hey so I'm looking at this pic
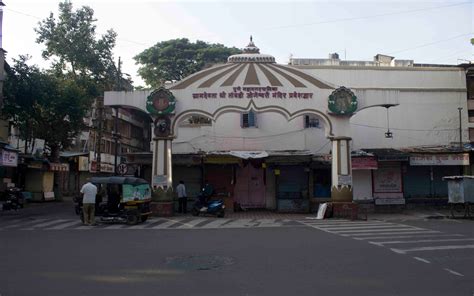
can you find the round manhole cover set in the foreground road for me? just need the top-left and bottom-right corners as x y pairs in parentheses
(166, 255), (234, 270)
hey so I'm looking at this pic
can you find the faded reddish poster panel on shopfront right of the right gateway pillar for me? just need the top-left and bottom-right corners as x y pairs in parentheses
(373, 164), (403, 193)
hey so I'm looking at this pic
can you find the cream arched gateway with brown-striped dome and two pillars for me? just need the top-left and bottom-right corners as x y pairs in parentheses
(105, 41), (398, 205)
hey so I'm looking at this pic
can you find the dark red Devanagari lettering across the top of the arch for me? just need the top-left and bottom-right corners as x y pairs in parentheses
(192, 86), (313, 100)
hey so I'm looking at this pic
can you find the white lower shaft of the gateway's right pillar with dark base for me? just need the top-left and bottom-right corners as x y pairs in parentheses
(331, 137), (352, 202)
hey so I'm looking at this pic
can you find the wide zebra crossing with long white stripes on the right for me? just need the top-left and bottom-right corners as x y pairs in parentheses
(302, 220), (474, 261)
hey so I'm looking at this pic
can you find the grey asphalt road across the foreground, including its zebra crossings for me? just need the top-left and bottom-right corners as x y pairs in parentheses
(0, 205), (474, 296)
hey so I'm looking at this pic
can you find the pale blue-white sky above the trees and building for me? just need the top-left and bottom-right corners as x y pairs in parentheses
(2, 0), (474, 86)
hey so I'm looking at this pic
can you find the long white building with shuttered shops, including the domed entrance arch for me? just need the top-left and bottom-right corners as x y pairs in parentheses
(104, 40), (469, 211)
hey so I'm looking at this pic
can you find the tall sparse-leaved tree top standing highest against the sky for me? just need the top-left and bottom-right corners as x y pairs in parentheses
(35, 1), (123, 95)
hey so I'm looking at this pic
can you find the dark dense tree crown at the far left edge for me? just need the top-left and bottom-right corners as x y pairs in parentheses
(3, 56), (91, 161)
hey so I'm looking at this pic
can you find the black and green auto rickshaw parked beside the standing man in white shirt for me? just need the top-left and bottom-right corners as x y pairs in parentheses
(75, 176), (151, 224)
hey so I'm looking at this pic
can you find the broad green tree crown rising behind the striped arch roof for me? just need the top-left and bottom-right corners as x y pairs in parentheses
(134, 38), (241, 87)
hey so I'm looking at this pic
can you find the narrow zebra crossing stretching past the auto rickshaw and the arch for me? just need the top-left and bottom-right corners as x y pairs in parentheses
(0, 217), (302, 233)
